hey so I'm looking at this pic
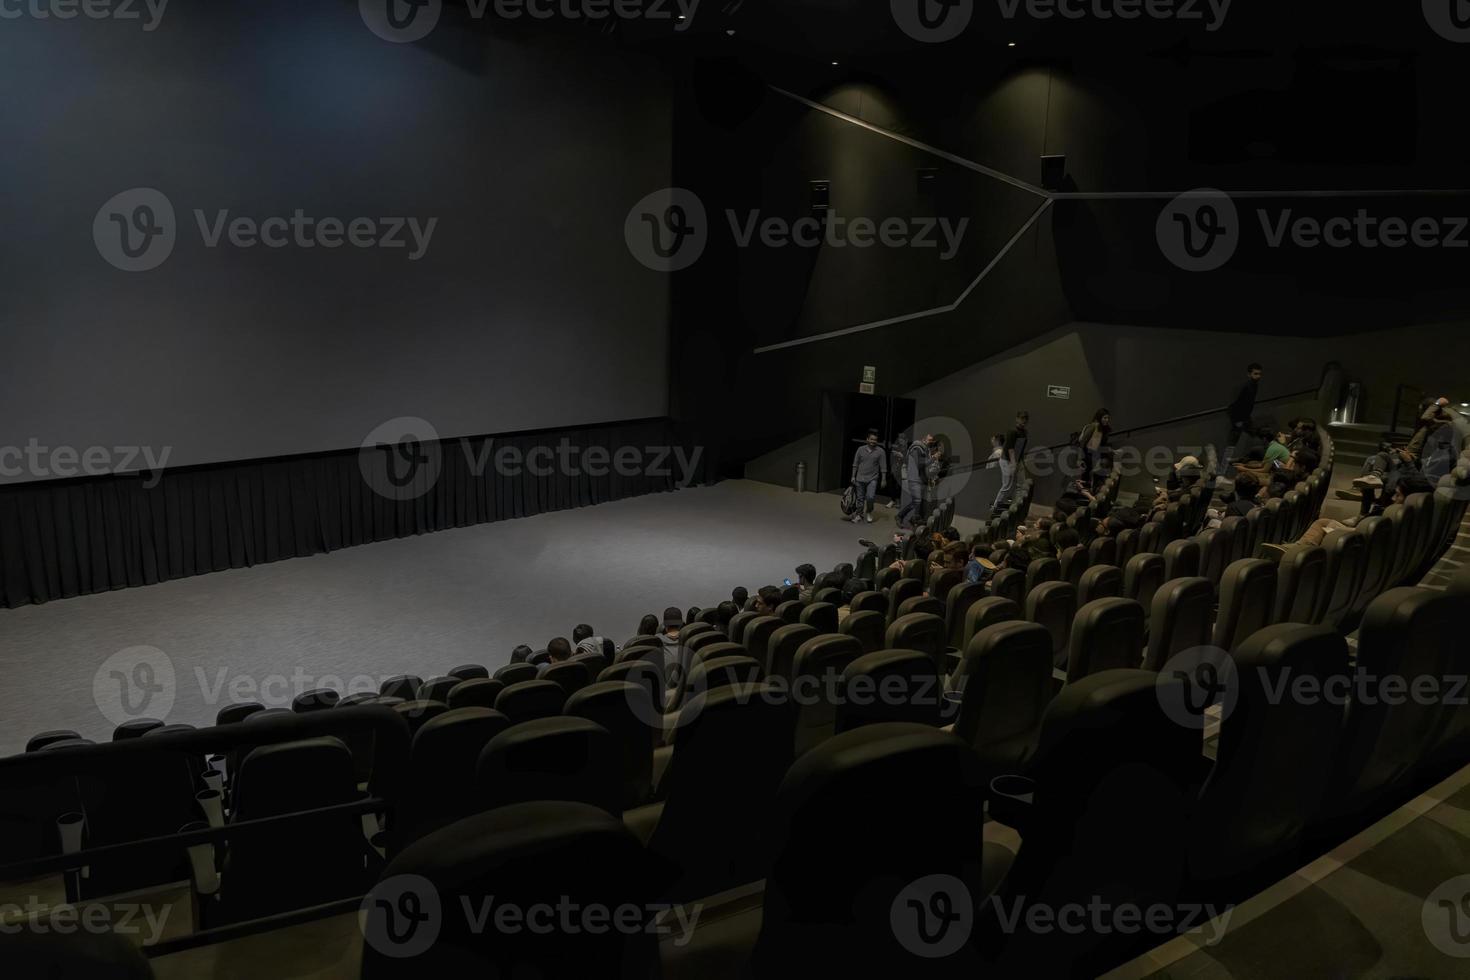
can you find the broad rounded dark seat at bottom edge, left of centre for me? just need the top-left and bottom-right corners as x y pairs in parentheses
(354, 802), (659, 980)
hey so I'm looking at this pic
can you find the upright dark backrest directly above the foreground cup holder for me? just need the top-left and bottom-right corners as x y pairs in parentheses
(951, 620), (1053, 752)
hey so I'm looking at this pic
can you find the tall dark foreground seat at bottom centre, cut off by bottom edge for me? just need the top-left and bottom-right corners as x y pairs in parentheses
(750, 723), (985, 977)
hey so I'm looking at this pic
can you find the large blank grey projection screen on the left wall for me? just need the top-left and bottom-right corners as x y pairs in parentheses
(0, 0), (670, 482)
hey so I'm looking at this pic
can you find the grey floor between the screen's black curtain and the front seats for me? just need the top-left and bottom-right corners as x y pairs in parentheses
(0, 480), (952, 754)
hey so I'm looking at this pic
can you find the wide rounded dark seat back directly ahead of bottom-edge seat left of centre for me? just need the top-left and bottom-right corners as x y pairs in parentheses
(475, 716), (623, 814)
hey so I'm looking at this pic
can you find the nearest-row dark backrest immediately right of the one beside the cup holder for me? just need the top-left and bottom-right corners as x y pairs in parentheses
(1189, 623), (1348, 886)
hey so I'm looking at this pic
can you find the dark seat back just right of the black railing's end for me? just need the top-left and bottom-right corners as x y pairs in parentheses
(392, 708), (510, 848)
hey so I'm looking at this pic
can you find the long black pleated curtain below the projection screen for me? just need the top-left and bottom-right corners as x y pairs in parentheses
(0, 419), (703, 608)
